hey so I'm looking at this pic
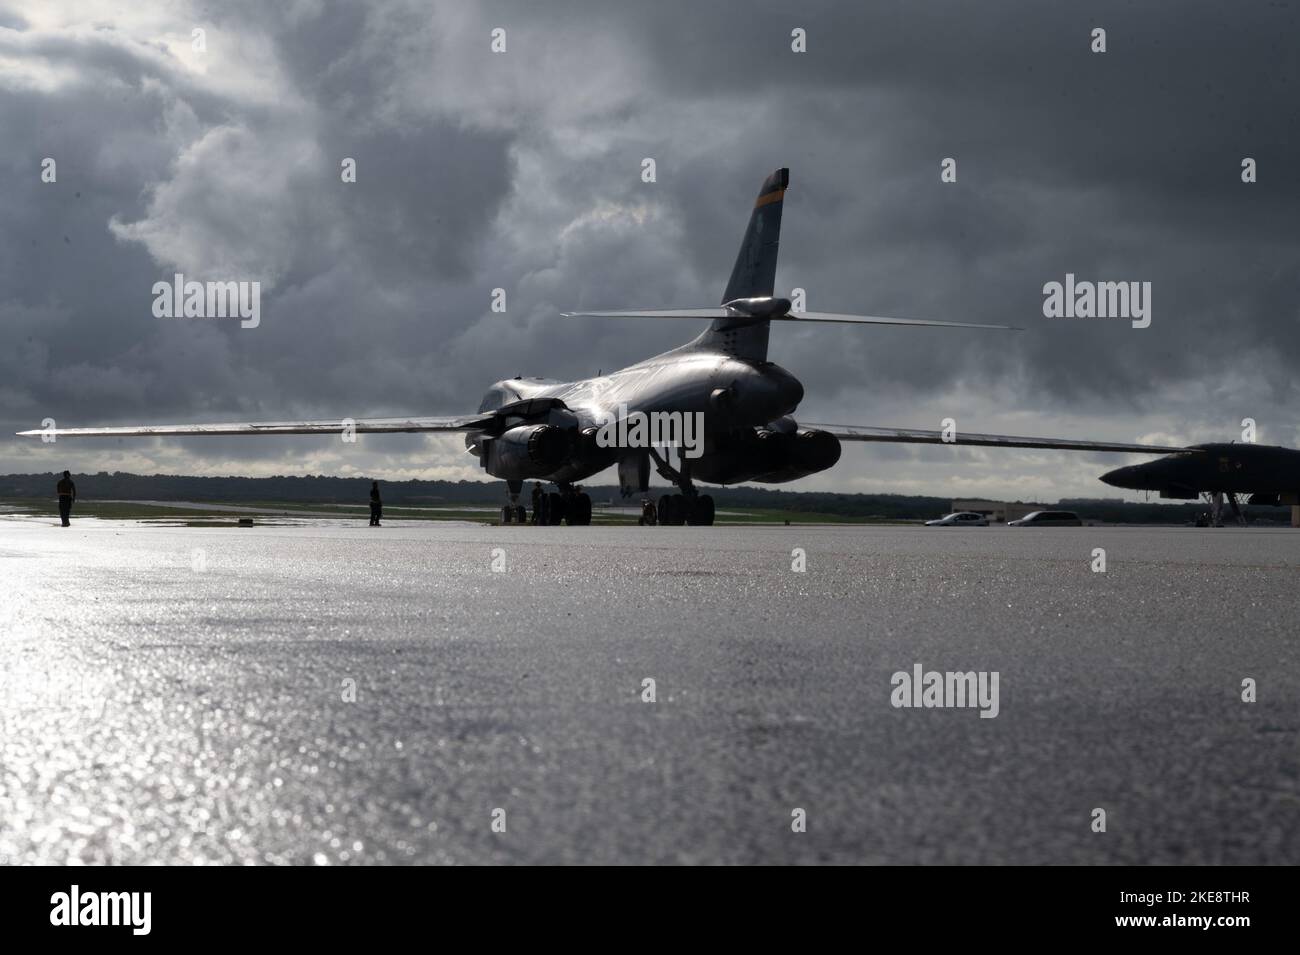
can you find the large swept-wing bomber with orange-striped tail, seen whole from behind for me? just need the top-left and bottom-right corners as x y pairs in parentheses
(21, 169), (1188, 525)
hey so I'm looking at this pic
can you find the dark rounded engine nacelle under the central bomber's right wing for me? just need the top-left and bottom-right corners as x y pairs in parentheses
(690, 421), (840, 485)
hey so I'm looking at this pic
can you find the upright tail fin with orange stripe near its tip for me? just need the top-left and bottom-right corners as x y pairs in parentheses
(696, 169), (790, 361)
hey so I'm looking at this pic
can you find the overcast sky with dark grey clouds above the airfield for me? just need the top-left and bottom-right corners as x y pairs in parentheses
(0, 0), (1300, 502)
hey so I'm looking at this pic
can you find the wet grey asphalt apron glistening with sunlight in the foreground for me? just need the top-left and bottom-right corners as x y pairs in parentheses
(0, 518), (1300, 864)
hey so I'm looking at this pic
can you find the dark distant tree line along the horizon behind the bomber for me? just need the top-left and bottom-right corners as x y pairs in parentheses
(0, 472), (1291, 524)
